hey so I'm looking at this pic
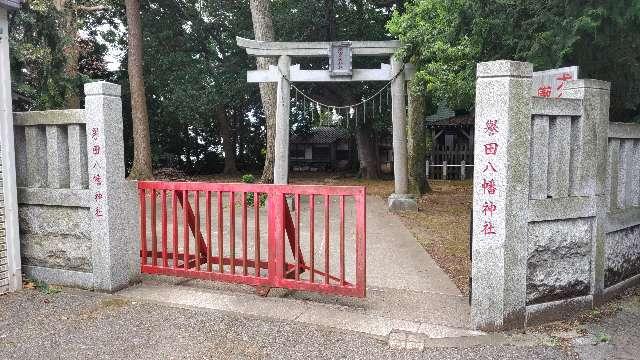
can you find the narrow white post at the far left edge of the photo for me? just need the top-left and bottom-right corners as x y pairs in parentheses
(0, 7), (22, 293)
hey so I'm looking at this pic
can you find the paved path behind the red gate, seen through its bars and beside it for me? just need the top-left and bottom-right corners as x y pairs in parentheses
(146, 193), (461, 296)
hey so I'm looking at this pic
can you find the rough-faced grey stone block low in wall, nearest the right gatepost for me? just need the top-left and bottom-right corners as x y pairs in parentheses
(527, 218), (593, 304)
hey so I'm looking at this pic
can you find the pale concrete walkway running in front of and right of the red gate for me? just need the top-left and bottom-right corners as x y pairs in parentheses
(124, 196), (480, 338)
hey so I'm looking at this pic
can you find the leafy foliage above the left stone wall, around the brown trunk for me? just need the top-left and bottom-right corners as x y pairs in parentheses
(9, 0), (114, 111)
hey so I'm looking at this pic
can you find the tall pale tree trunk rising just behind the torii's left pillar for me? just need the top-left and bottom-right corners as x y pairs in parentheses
(249, 0), (277, 183)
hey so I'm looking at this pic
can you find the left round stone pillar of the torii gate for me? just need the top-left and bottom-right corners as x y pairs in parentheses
(273, 55), (291, 184)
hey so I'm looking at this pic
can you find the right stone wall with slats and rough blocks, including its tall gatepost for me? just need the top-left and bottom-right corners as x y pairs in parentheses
(472, 61), (640, 329)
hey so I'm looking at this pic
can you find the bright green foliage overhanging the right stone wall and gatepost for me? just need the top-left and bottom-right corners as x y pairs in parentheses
(387, 0), (640, 121)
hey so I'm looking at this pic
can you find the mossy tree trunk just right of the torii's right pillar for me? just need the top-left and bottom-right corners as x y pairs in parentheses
(407, 88), (429, 195)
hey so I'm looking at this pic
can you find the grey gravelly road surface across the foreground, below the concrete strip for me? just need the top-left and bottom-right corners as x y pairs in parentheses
(0, 289), (573, 360)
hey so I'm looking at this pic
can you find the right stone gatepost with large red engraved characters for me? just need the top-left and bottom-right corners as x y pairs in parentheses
(471, 61), (533, 330)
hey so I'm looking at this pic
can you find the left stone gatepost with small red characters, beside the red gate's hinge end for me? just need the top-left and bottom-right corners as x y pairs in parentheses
(84, 81), (139, 292)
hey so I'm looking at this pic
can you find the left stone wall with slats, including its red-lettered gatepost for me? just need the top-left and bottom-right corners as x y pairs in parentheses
(14, 82), (137, 291)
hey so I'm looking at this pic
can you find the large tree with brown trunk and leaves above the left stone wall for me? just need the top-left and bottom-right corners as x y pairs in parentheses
(10, 0), (113, 110)
